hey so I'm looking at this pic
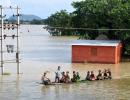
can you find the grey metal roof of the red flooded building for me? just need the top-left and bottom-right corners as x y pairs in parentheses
(72, 40), (121, 46)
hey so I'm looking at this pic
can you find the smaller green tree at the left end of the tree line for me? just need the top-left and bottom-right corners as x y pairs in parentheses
(44, 10), (73, 35)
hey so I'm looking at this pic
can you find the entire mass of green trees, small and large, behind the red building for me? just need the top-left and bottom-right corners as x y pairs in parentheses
(44, 0), (130, 55)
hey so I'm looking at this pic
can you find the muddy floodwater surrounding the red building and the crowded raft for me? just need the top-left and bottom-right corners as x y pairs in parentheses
(0, 25), (130, 100)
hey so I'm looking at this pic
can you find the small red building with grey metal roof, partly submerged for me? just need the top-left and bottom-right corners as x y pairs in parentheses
(72, 40), (122, 64)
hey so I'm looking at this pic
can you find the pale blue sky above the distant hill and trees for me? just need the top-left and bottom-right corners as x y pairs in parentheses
(0, 0), (81, 18)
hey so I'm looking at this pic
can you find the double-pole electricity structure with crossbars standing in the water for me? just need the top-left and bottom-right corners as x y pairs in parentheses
(0, 5), (20, 75)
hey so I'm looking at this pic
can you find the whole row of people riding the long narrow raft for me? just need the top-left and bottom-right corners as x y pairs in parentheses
(41, 66), (112, 85)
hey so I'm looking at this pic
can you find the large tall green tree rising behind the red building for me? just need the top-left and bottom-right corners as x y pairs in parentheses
(72, 0), (130, 40)
